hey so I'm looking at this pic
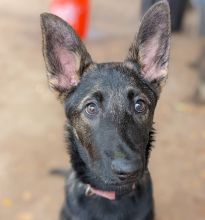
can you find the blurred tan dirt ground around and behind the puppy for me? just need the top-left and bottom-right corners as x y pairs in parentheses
(0, 0), (205, 220)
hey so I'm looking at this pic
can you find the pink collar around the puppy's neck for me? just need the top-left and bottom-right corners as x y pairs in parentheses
(86, 183), (136, 201)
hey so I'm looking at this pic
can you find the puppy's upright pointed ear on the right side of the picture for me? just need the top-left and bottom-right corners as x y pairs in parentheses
(125, 0), (170, 90)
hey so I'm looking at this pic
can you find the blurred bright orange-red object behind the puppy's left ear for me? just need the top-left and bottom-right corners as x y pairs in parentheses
(50, 0), (89, 39)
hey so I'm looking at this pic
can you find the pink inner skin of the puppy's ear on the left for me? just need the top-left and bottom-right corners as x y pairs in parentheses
(55, 48), (79, 89)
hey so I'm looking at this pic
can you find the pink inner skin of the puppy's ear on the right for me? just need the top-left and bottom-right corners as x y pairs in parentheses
(139, 35), (165, 80)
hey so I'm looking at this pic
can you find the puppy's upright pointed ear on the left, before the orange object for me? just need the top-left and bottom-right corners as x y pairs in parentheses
(41, 13), (92, 94)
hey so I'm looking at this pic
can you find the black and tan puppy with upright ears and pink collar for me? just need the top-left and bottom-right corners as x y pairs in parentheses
(41, 1), (170, 220)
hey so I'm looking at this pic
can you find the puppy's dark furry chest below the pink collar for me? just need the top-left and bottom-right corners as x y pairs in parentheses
(61, 174), (153, 220)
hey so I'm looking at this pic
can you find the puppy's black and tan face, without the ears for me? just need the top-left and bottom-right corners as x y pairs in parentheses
(65, 63), (157, 190)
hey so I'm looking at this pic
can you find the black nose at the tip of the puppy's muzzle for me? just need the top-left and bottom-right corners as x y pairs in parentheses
(111, 159), (141, 180)
